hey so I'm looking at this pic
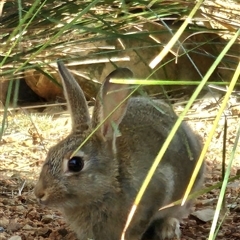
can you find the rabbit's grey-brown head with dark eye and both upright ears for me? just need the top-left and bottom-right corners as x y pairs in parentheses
(35, 62), (132, 208)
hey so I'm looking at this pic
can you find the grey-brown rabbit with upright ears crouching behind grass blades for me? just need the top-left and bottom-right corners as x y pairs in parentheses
(34, 61), (204, 240)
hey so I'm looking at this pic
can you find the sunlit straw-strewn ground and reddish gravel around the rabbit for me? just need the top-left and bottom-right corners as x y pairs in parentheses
(0, 93), (240, 240)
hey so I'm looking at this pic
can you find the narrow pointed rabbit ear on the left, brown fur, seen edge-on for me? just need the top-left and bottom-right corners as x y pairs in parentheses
(57, 61), (90, 132)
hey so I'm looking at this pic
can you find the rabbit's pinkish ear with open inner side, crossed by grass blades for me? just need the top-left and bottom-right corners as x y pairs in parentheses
(93, 68), (133, 140)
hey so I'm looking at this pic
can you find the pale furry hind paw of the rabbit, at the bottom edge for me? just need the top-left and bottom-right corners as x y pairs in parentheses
(159, 218), (181, 240)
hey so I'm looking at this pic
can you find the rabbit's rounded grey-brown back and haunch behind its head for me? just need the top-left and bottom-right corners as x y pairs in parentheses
(113, 97), (204, 239)
